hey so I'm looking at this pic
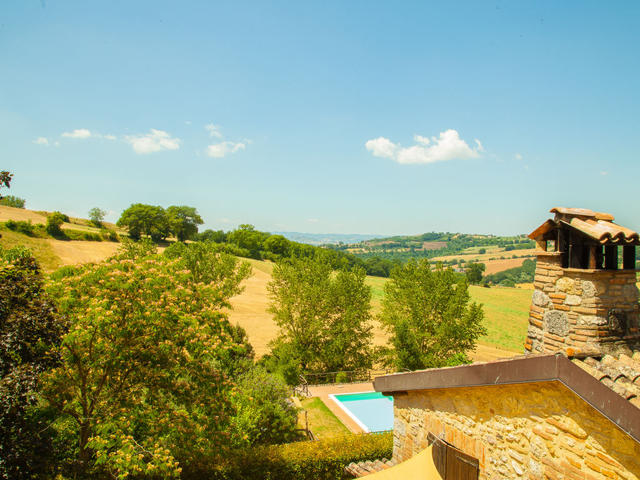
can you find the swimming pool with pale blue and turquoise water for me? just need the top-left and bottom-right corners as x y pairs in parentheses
(329, 392), (393, 432)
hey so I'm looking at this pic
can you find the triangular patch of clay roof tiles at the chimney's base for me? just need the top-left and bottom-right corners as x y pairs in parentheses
(571, 351), (640, 408)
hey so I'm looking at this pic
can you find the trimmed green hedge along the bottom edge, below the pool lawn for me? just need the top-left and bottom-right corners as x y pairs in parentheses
(202, 432), (393, 480)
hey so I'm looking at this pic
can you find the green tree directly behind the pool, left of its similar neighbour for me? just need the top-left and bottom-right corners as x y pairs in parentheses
(268, 257), (372, 382)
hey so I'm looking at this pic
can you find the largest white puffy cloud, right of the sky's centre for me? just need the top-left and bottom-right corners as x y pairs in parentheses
(365, 129), (484, 165)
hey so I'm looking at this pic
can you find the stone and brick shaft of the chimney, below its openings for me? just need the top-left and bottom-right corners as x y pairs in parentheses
(525, 252), (640, 355)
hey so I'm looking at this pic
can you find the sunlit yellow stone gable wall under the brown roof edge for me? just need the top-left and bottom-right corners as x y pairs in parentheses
(393, 382), (640, 480)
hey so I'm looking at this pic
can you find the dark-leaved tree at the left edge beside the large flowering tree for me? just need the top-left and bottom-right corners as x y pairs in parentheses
(0, 247), (65, 479)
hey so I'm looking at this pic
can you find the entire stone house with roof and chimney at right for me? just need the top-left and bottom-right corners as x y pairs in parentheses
(362, 208), (640, 480)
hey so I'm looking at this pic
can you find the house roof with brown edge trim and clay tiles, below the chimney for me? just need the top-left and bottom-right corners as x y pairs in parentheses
(373, 353), (640, 443)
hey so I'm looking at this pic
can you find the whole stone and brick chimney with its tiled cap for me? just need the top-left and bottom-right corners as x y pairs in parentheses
(525, 207), (640, 356)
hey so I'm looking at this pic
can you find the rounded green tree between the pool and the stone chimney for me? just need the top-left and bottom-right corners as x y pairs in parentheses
(380, 260), (486, 370)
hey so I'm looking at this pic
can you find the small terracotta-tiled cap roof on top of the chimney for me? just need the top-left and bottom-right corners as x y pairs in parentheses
(529, 207), (640, 245)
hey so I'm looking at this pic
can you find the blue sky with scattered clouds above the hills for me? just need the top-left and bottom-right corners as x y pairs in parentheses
(0, 0), (640, 234)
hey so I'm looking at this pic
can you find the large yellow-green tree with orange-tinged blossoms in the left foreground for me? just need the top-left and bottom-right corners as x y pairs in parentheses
(44, 249), (247, 478)
